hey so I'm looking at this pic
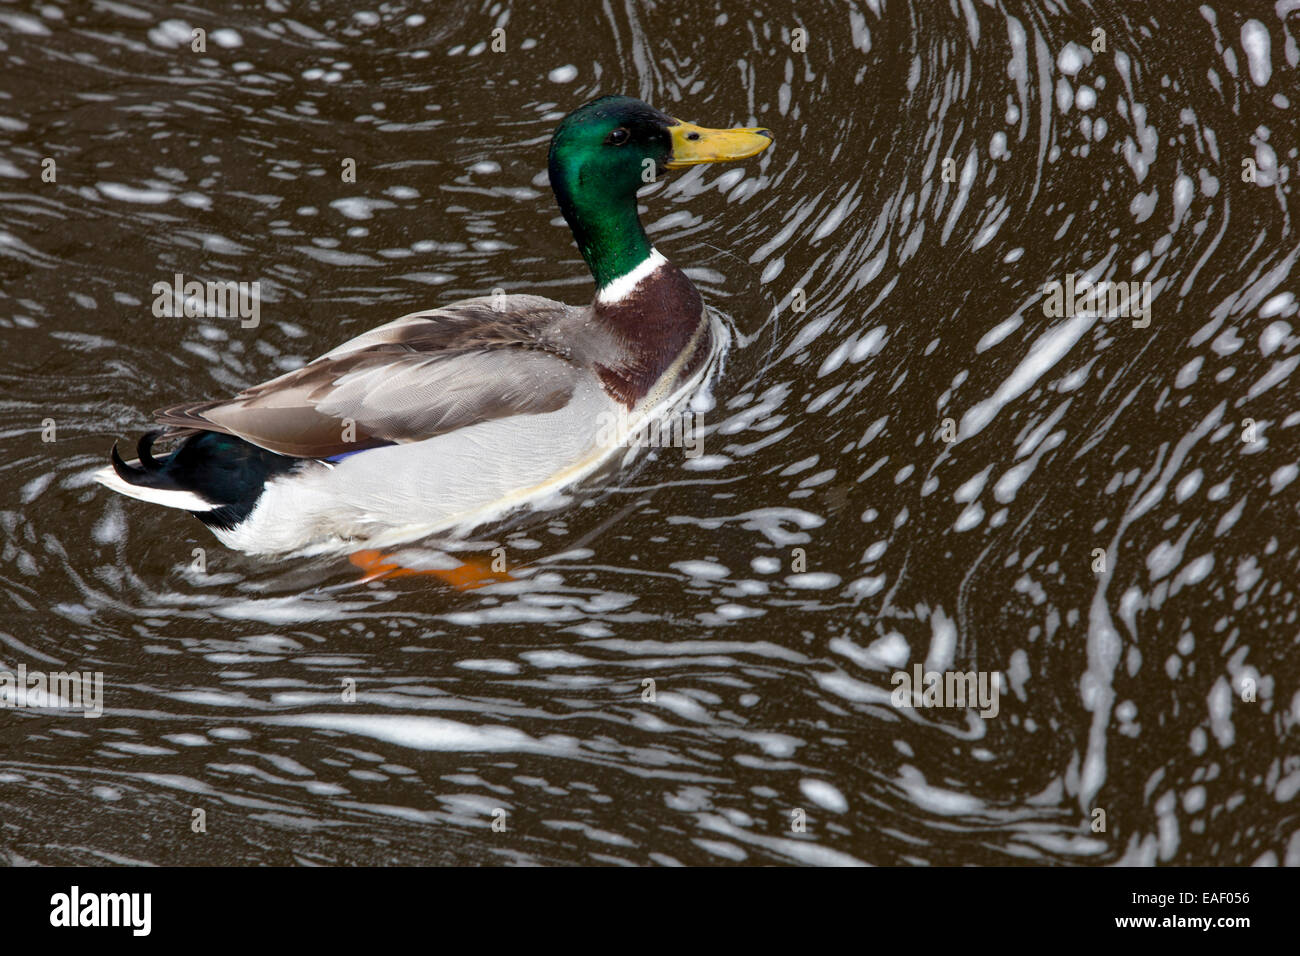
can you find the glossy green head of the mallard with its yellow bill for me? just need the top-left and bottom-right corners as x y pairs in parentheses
(540, 96), (772, 287)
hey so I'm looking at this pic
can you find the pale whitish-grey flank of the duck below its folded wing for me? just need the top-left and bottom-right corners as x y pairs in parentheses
(212, 310), (728, 555)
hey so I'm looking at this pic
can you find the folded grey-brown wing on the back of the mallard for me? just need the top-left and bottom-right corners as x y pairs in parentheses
(156, 295), (582, 458)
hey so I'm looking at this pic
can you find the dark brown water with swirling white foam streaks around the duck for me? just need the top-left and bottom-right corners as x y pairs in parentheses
(0, 0), (1300, 864)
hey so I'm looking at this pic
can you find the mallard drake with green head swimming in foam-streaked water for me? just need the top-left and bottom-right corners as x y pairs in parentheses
(95, 96), (774, 555)
